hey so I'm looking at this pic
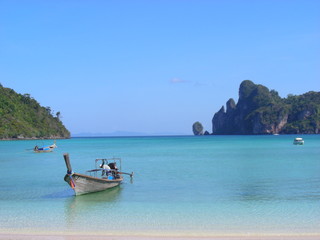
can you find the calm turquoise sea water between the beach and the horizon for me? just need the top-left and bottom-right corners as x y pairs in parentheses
(0, 135), (320, 236)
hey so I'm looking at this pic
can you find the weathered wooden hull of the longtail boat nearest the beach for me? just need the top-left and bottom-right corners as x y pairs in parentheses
(64, 173), (123, 195)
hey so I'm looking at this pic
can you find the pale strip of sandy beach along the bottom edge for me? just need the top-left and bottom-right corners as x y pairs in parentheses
(0, 230), (320, 240)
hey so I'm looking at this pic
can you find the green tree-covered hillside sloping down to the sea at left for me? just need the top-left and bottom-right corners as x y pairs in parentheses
(0, 84), (70, 139)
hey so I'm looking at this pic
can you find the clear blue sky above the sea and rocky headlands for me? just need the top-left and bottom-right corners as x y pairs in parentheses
(0, 0), (320, 134)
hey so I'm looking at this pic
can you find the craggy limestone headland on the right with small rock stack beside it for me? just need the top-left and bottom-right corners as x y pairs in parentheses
(192, 80), (320, 135)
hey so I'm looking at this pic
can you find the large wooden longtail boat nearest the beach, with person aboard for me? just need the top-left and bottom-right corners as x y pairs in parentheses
(63, 153), (133, 195)
